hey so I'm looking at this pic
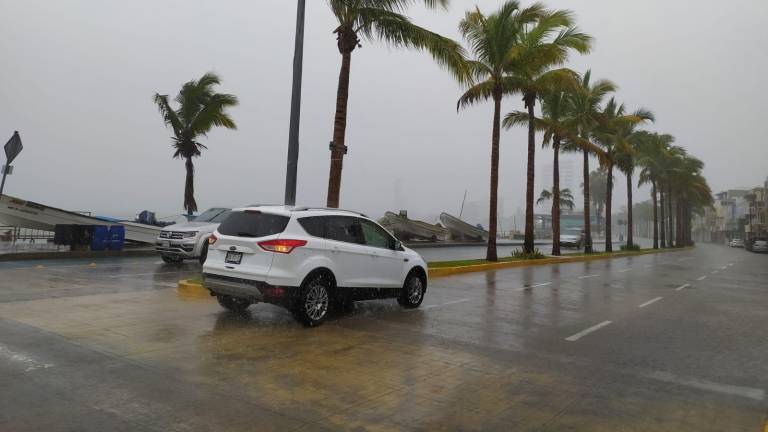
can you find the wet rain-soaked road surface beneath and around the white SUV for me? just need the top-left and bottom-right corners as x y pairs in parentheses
(0, 245), (768, 431)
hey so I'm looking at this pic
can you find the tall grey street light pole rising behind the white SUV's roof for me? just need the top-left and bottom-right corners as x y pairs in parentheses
(285, 0), (306, 205)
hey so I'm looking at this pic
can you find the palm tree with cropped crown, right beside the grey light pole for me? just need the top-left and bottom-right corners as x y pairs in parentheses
(327, 0), (466, 208)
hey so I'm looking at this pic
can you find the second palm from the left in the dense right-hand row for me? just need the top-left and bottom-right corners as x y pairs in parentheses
(508, 10), (592, 253)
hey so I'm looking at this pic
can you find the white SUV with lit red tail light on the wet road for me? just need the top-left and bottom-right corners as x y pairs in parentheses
(203, 206), (427, 326)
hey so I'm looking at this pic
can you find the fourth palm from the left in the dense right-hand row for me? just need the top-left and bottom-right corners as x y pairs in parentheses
(565, 70), (616, 253)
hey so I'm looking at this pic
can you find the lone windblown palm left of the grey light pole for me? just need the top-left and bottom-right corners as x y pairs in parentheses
(154, 72), (238, 215)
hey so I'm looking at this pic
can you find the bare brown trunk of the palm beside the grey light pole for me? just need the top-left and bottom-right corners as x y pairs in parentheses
(327, 51), (352, 208)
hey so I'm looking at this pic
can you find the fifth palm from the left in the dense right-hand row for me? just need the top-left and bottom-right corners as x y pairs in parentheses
(595, 98), (653, 252)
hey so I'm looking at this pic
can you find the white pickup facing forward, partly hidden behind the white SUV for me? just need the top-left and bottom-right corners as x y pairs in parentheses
(155, 208), (231, 264)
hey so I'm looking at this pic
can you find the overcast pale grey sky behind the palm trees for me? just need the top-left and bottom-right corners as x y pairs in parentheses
(0, 0), (768, 226)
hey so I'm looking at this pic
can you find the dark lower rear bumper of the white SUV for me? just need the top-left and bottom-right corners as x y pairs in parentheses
(203, 273), (295, 304)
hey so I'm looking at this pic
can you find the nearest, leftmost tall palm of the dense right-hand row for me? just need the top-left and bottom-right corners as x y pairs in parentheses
(457, 0), (546, 261)
